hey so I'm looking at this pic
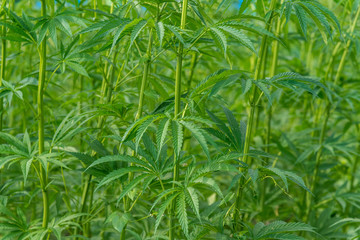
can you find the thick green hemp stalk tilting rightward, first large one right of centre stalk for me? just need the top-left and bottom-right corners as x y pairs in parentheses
(233, 0), (277, 230)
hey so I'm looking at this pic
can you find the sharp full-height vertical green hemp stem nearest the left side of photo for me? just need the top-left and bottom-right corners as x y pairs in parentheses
(37, 0), (49, 231)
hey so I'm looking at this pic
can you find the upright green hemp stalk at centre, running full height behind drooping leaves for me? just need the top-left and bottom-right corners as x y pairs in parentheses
(169, 0), (188, 240)
